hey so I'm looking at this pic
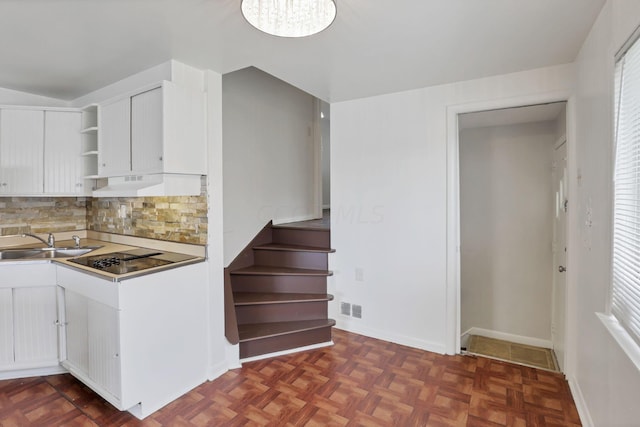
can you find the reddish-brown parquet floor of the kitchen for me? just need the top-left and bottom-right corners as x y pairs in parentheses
(0, 330), (580, 427)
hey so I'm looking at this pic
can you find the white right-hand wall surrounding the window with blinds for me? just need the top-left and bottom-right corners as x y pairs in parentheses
(570, 0), (640, 427)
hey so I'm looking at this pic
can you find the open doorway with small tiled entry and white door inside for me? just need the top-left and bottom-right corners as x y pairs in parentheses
(458, 102), (568, 370)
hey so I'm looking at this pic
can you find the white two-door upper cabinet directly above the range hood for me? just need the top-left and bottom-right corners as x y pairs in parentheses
(99, 81), (206, 177)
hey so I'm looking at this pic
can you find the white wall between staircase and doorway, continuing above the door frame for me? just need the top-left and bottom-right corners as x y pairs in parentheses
(329, 61), (574, 353)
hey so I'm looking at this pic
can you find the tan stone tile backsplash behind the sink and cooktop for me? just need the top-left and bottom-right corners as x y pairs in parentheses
(0, 188), (208, 245)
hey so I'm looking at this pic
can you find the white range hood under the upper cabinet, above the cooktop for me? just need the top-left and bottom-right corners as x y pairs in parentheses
(92, 174), (201, 197)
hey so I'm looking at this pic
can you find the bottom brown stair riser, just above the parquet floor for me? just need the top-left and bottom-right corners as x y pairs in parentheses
(240, 327), (331, 359)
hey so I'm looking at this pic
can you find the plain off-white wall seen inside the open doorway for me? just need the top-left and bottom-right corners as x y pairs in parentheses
(459, 121), (556, 343)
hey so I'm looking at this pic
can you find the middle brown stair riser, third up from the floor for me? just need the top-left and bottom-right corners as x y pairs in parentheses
(231, 275), (327, 294)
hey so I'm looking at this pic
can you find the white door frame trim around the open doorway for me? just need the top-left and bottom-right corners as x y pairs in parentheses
(445, 91), (578, 375)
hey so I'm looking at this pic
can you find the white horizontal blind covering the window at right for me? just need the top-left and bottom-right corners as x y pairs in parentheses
(611, 34), (640, 345)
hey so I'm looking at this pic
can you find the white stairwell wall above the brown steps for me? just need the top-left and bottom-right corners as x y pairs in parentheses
(222, 68), (317, 265)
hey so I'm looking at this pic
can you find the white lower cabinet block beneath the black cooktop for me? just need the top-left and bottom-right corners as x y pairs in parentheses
(57, 263), (208, 418)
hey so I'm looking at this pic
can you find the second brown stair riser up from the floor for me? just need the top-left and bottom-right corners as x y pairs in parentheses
(236, 301), (327, 325)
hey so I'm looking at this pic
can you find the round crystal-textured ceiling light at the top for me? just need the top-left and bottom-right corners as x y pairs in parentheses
(240, 0), (337, 37)
